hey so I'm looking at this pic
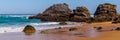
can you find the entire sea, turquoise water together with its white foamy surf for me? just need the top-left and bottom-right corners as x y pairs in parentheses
(0, 14), (79, 33)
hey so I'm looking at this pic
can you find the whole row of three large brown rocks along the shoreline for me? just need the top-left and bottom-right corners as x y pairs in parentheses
(29, 3), (120, 23)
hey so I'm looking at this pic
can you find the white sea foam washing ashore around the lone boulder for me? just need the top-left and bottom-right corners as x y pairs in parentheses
(0, 22), (80, 33)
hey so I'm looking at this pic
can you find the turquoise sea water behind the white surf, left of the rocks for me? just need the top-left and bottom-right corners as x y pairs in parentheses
(0, 14), (41, 27)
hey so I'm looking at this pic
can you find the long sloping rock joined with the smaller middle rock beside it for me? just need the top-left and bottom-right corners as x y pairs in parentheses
(29, 3), (90, 22)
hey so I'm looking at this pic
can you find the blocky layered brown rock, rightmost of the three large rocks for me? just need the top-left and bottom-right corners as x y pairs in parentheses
(94, 3), (117, 22)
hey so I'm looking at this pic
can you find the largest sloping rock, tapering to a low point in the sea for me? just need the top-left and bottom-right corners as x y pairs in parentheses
(29, 3), (71, 21)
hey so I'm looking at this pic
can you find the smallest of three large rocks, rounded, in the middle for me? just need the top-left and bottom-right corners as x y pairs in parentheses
(70, 6), (91, 22)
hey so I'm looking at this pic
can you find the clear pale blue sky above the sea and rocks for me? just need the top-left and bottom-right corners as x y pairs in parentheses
(0, 0), (120, 14)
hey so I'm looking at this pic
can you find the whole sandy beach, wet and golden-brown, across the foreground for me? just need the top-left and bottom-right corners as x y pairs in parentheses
(0, 22), (120, 40)
